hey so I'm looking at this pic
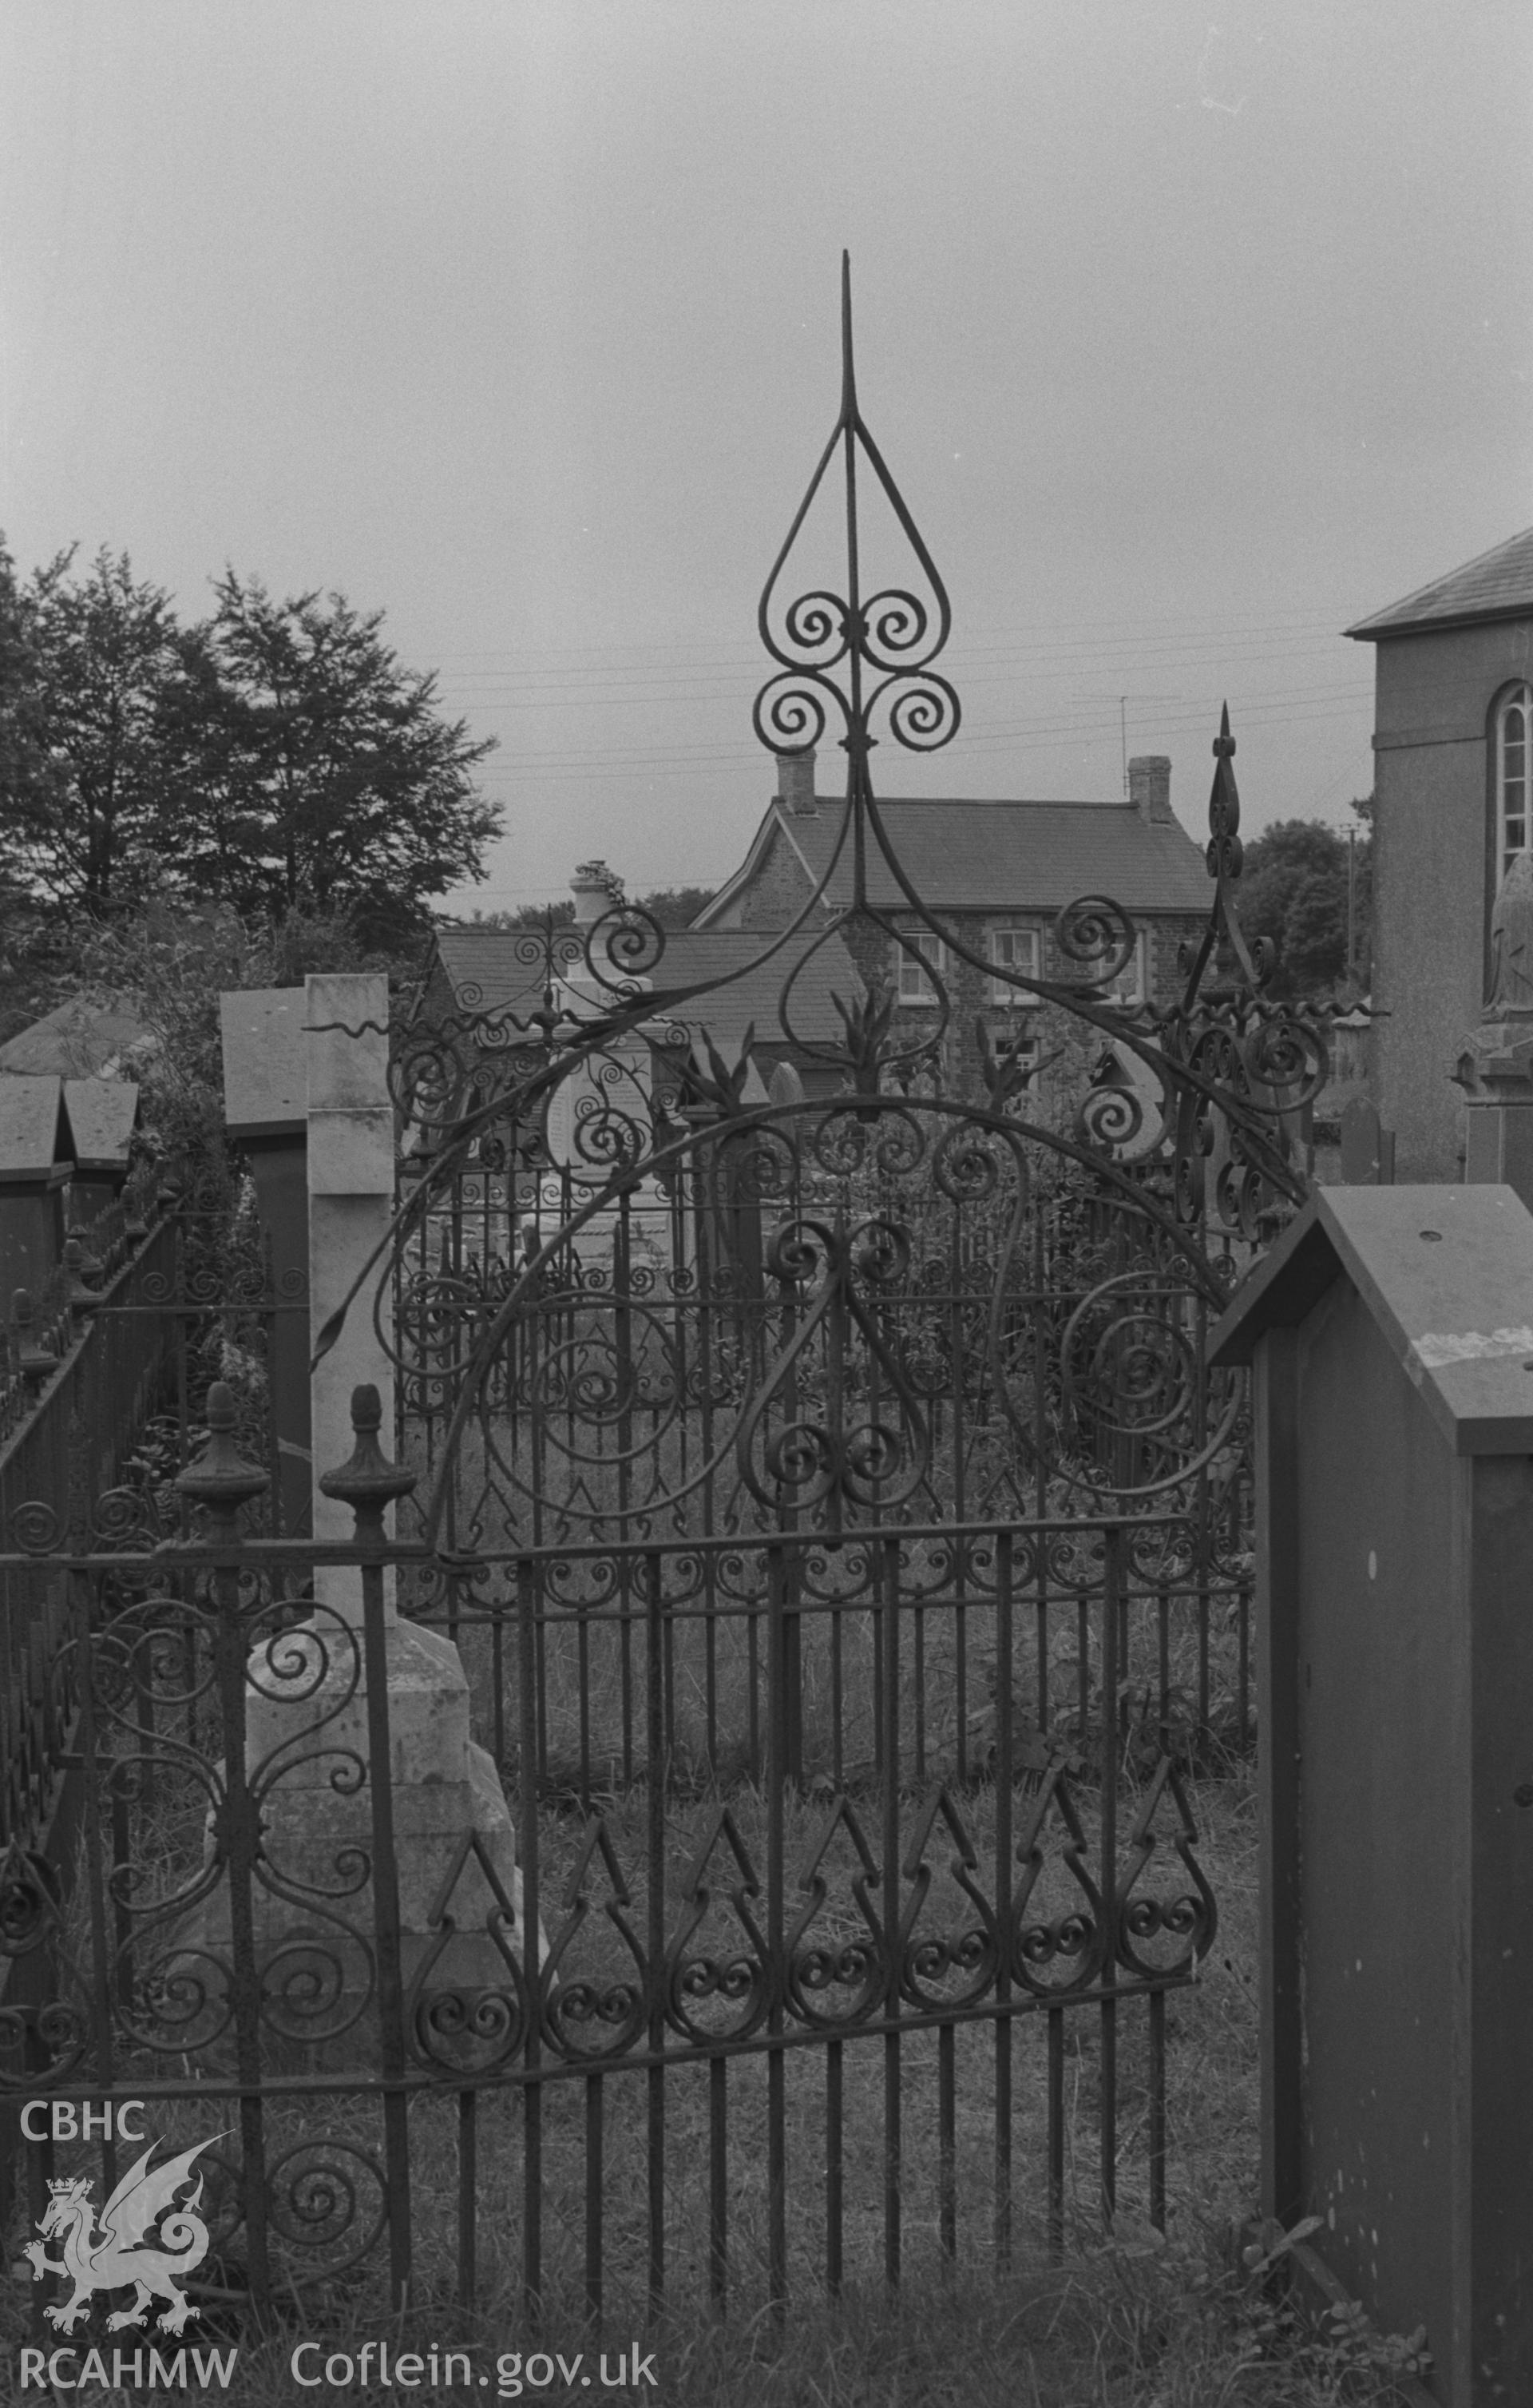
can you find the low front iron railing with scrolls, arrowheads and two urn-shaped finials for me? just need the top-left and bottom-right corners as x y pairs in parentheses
(0, 1392), (1215, 2316)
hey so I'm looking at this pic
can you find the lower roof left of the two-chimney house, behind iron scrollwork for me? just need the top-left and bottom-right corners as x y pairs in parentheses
(436, 927), (862, 1053)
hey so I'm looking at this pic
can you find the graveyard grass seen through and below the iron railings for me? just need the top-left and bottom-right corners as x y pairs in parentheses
(0, 1493), (1393, 2408)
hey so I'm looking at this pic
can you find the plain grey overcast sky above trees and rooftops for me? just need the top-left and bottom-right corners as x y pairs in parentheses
(0, 0), (1533, 908)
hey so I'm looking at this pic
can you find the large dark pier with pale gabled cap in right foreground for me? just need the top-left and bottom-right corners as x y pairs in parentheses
(1210, 1184), (1533, 2408)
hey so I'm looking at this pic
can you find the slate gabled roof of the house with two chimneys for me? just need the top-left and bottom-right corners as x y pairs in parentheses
(695, 797), (1210, 927)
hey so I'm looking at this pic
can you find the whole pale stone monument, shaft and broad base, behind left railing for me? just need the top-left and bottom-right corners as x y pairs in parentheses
(186, 973), (546, 2066)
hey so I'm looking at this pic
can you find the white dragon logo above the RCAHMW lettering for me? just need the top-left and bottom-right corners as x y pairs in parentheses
(24, 2133), (221, 2334)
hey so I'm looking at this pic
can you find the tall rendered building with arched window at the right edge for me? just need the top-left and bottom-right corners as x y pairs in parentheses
(1348, 527), (1533, 1180)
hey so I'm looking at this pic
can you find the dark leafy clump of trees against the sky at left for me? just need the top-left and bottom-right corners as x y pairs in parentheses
(0, 537), (498, 944)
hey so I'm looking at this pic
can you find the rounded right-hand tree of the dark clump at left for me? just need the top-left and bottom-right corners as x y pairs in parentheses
(178, 571), (501, 939)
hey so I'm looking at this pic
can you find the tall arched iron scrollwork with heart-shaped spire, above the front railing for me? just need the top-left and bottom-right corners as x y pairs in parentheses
(347, 263), (1329, 1541)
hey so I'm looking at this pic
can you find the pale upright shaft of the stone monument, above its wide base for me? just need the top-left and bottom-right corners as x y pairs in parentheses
(303, 970), (394, 1623)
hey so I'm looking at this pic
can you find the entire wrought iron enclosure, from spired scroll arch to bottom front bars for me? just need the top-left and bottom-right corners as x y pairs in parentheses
(0, 259), (1326, 2314)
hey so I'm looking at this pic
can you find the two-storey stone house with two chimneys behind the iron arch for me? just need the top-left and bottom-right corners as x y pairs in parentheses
(693, 752), (1210, 1093)
